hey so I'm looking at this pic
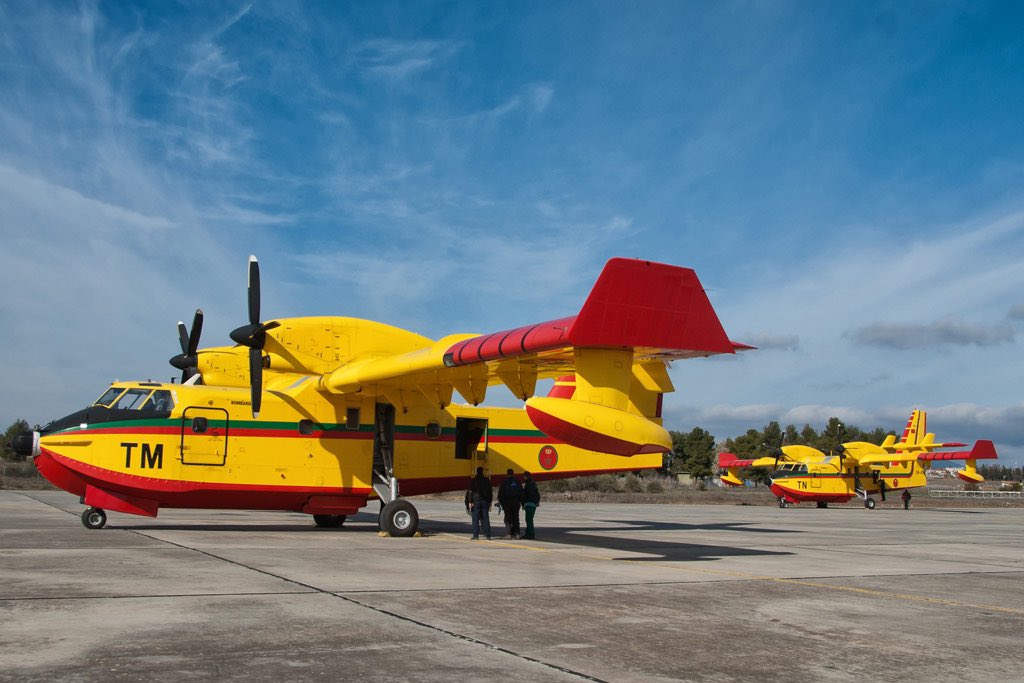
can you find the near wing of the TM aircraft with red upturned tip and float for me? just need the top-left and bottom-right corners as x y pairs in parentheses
(321, 258), (753, 455)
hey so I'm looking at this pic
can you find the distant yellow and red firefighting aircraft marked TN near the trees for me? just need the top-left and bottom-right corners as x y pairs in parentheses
(718, 410), (996, 510)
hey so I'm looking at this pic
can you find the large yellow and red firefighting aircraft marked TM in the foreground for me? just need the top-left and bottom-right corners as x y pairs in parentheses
(14, 257), (752, 536)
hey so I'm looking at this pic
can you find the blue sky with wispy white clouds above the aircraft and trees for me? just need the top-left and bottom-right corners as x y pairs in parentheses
(0, 1), (1024, 462)
